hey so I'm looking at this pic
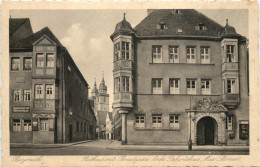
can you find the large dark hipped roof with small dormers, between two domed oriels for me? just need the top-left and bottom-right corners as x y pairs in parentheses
(134, 9), (223, 37)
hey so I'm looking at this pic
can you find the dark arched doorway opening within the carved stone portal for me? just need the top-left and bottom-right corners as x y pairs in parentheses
(197, 116), (218, 145)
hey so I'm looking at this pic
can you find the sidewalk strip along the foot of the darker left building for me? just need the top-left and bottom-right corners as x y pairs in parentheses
(10, 140), (95, 148)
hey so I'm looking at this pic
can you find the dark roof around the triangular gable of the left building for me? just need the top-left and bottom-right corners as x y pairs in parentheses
(10, 27), (63, 48)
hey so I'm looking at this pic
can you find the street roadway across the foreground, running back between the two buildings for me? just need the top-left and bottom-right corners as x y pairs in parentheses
(10, 140), (248, 155)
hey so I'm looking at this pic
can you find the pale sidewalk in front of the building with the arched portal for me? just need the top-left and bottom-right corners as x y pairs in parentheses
(107, 141), (249, 151)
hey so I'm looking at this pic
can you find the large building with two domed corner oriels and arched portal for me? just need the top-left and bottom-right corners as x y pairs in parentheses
(110, 9), (249, 145)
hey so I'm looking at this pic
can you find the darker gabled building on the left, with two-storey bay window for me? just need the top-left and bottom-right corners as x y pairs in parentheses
(9, 19), (96, 144)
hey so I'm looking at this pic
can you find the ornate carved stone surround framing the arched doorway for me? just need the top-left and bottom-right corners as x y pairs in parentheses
(187, 98), (228, 145)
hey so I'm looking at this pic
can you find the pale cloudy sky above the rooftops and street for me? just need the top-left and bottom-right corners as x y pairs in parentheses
(10, 9), (248, 111)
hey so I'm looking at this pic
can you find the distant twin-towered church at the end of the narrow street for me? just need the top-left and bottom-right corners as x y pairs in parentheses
(90, 76), (109, 139)
